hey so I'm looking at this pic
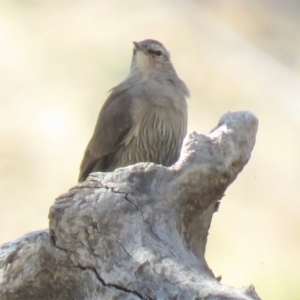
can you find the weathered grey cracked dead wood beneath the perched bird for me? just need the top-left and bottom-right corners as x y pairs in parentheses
(0, 111), (260, 300)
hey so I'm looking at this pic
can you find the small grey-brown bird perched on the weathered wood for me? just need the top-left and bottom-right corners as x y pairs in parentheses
(78, 39), (189, 182)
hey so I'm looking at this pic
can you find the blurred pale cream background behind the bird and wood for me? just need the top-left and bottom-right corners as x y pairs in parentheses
(0, 0), (300, 299)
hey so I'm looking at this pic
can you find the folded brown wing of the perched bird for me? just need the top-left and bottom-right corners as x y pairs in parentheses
(79, 85), (132, 182)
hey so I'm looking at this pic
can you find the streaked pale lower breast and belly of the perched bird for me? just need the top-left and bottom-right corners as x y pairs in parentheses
(121, 103), (187, 166)
